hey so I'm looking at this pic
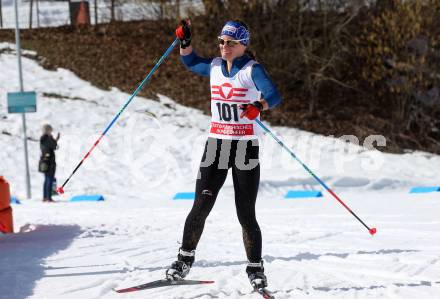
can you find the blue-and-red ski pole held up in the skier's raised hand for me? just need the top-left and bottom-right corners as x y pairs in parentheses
(57, 38), (179, 194)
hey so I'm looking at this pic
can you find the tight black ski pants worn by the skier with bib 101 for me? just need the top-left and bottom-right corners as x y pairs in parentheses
(182, 138), (262, 263)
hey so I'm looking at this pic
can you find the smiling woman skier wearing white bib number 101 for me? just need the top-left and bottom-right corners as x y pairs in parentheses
(166, 20), (281, 289)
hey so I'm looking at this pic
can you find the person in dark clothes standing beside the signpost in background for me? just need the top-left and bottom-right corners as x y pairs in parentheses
(39, 124), (60, 202)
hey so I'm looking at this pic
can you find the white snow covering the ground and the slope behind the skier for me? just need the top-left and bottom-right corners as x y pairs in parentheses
(0, 43), (440, 299)
